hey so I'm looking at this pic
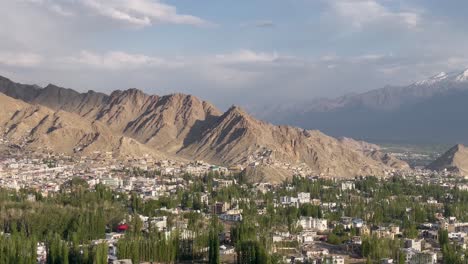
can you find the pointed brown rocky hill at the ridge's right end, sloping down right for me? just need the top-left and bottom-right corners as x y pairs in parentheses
(179, 107), (398, 177)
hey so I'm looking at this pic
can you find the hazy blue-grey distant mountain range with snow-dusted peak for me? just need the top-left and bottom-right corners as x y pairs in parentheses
(254, 70), (468, 143)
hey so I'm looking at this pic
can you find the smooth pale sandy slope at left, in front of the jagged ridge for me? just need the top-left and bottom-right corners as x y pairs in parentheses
(0, 94), (162, 157)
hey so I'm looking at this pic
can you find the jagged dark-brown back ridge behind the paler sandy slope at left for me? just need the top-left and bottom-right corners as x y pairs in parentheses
(0, 78), (220, 154)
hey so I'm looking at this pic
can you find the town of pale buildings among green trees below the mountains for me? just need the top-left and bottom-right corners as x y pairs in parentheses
(0, 147), (468, 264)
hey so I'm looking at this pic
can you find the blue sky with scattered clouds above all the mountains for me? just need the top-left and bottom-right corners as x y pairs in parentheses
(0, 0), (468, 108)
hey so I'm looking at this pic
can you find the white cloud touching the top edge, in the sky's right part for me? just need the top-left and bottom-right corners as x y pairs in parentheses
(327, 0), (422, 30)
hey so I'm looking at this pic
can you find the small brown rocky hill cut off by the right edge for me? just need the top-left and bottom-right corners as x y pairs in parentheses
(427, 144), (468, 176)
